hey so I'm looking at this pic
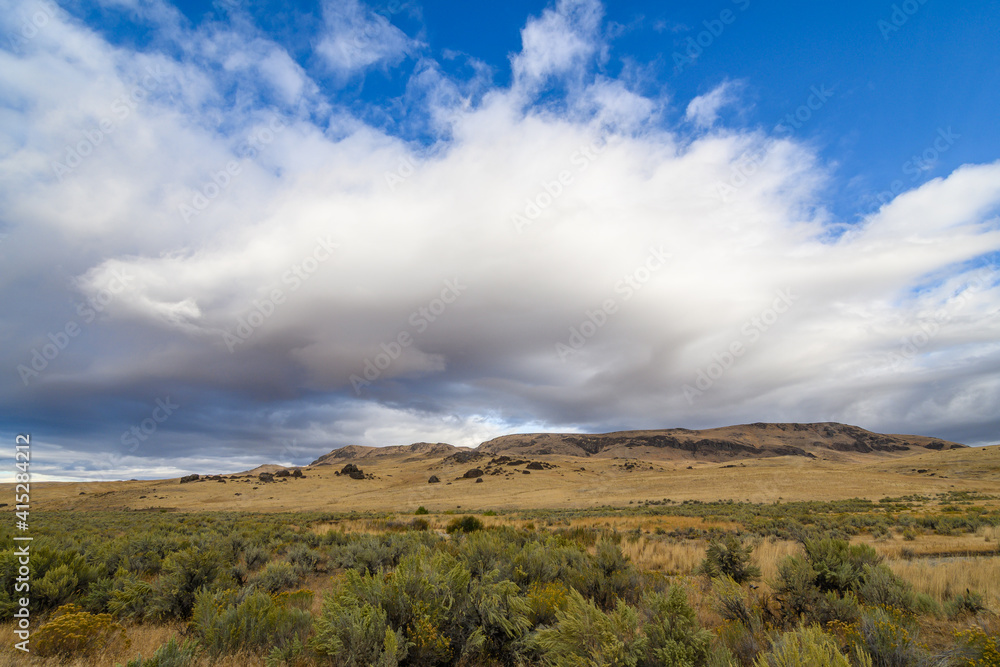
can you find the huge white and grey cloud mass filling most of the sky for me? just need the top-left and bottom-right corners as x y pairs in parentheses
(0, 2), (1000, 480)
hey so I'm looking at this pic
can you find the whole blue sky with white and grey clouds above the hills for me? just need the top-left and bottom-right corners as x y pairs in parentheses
(0, 0), (1000, 480)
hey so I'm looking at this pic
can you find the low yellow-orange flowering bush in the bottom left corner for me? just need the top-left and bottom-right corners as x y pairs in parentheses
(34, 604), (129, 658)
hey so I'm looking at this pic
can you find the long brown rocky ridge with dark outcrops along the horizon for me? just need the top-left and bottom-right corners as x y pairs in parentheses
(311, 422), (966, 465)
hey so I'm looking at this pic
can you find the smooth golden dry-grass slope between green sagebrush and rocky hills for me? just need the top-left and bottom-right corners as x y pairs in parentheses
(9, 446), (1000, 512)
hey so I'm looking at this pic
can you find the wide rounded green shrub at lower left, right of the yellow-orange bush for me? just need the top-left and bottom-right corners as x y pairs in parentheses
(191, 589), (312, 657)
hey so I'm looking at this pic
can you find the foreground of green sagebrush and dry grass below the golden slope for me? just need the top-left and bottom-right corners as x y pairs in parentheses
(0, 492), (1000, 667)
